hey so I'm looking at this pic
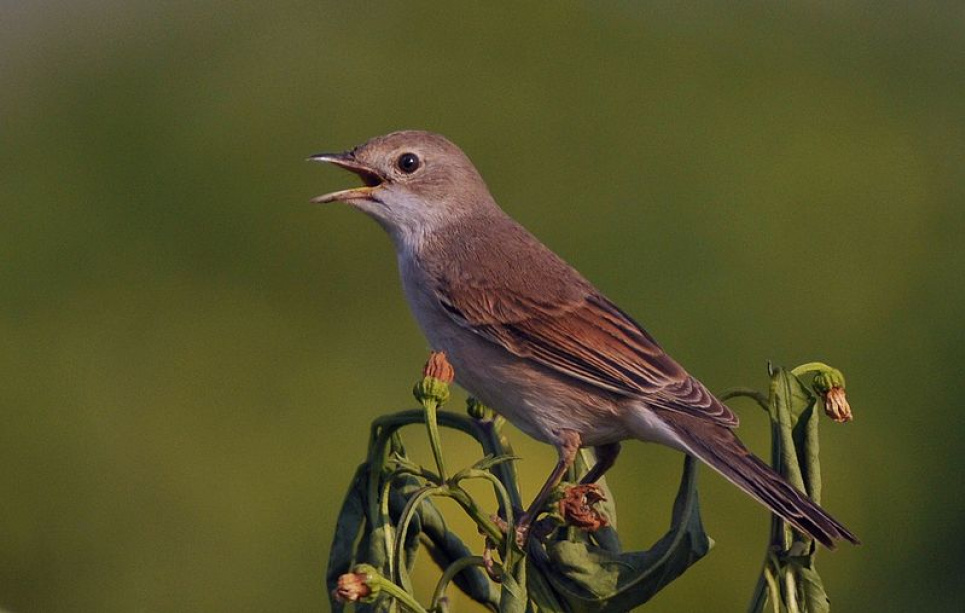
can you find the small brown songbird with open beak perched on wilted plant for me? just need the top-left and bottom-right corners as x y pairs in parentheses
(308, 130), (859, 548)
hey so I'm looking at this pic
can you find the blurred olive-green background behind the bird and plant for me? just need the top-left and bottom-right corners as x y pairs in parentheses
(0, 0), (965, 612)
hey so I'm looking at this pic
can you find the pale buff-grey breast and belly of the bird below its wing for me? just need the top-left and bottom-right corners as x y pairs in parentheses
(400, 262), (632, 446)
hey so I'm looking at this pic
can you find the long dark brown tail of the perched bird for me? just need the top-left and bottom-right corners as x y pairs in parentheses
(660, 411), (859, 549)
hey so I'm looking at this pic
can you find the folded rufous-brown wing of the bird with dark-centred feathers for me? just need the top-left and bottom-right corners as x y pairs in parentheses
(436, 285), (738, 427)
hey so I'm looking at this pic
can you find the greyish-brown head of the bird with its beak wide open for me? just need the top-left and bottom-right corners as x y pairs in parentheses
(308, 130), (495, 239)
